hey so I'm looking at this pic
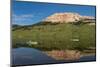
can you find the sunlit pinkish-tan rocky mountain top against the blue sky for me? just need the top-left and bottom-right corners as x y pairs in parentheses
(43, 12), (95, 23)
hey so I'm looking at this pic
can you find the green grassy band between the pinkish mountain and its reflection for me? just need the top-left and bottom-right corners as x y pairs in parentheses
(12, 24), (95, 50)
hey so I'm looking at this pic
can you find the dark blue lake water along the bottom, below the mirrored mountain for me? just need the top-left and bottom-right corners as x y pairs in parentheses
(12, 47), (96, 65)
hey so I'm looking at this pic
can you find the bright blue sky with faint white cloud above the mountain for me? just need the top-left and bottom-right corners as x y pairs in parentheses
(12, 1), (95, 25)
